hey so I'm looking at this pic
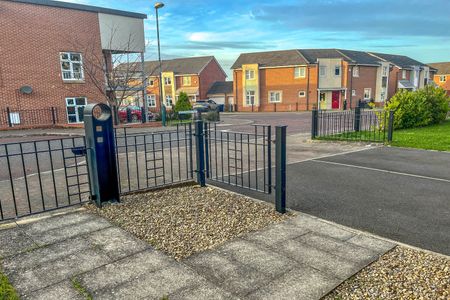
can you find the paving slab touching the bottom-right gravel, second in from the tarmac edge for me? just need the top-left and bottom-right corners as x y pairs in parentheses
(297, 233), (379, 263)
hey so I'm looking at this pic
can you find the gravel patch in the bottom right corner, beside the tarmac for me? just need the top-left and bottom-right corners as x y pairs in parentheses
(323, 246), (450, 300)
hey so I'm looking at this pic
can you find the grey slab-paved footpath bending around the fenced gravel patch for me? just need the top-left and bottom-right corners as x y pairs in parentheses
(0, 209), (395, 300)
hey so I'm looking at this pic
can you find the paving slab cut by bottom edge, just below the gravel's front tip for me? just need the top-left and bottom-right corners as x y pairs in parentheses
(95, 264), (204, 300)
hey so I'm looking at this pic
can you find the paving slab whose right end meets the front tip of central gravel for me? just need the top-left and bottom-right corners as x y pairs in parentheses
(77, 249), (175, 295)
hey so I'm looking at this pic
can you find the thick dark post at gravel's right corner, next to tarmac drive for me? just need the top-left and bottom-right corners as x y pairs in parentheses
(275, 126), (287, 214)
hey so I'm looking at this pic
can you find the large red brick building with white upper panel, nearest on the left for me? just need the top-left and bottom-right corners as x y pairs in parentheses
(0, 0), (146, 127)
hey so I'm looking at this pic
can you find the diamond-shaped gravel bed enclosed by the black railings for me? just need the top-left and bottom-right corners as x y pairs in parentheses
(86, 185), (290, 260)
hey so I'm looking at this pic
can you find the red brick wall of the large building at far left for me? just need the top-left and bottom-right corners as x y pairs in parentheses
(0, 1), (104, 124)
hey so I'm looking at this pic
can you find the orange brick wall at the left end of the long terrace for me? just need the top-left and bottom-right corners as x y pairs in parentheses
(233, 66), (317, 112)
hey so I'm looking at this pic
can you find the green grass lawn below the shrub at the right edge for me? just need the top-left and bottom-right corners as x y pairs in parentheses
(391, 119), (450, 151)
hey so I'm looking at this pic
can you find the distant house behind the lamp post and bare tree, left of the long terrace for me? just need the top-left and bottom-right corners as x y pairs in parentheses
(144, 56), (227, 111)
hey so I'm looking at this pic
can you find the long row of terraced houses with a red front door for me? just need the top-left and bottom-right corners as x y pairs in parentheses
(232, 49), (430, 111)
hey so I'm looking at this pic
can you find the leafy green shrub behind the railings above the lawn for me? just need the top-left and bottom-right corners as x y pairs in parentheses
(385, 86), (449, 129)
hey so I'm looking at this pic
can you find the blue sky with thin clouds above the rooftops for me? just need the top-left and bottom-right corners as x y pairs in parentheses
(63, 0), (450, 79)
